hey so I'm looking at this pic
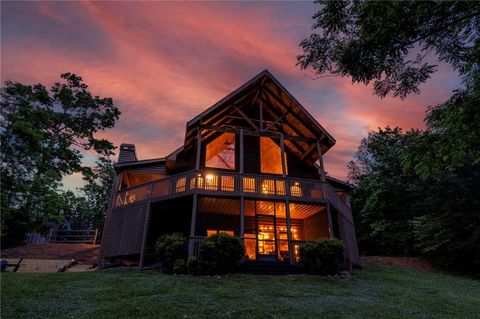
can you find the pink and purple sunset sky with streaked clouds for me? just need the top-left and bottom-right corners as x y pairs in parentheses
(1, 2), (460, 187)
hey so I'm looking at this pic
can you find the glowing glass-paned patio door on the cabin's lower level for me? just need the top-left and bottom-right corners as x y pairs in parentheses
(257, 215), (277, 261)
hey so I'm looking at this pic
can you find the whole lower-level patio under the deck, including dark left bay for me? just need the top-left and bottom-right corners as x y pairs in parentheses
(147, 196), (339, 263)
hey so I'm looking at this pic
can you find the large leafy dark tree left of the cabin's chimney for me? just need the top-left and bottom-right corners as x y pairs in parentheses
(0, 73), (120, 246)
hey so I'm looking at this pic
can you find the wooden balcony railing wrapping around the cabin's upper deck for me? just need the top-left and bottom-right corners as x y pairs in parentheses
(115, 171), (325, 207)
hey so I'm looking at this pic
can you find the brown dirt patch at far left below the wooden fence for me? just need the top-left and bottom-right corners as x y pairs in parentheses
(1, 243), (100, 265)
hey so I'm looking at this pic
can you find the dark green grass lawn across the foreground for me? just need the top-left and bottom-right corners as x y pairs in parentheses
(1, 265), (480, 319)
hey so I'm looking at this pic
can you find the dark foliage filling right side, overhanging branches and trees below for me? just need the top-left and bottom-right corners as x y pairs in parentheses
(304, 0), (480, 271)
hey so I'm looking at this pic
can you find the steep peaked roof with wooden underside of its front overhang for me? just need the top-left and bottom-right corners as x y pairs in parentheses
(184, 70), (335, 160)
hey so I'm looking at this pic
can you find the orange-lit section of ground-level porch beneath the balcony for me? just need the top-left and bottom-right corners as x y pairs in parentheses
(189, 196), (333, 263)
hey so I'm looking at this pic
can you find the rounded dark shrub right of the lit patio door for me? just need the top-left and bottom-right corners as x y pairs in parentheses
(300, 238), (343, 275)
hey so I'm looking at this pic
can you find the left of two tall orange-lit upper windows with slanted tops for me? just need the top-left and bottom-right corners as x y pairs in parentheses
(205, 133), (235, 170)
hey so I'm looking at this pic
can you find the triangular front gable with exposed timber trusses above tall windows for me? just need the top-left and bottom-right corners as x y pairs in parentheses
(184, 70), (335, 168)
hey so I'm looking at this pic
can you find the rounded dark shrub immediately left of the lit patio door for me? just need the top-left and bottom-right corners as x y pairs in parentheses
(194, 233), (245, 275)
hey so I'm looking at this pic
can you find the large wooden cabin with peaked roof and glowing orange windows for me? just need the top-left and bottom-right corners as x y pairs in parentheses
(100, 70), (360, 267)
